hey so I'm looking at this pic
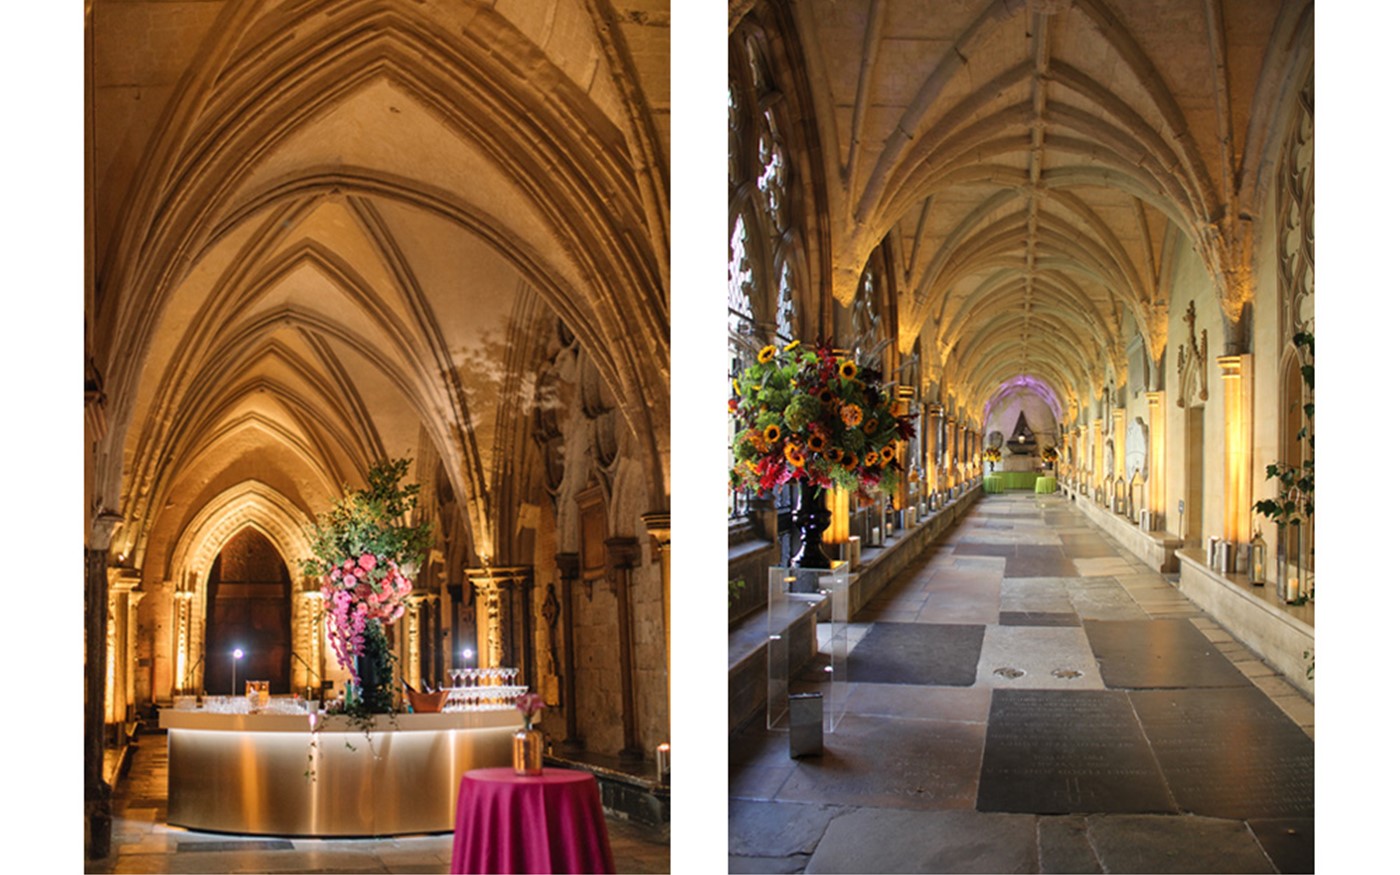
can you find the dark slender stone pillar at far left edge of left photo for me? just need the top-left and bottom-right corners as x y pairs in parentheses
(83, 512), (122, 860)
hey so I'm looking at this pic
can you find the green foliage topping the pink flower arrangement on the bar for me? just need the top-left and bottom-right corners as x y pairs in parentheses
(302, 459), (433, 577)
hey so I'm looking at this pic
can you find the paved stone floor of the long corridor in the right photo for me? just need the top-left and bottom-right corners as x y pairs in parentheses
(729, 491), (1315, 872)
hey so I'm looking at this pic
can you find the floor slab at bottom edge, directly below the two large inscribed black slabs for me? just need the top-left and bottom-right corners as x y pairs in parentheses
(1088, 816), (1274, 872)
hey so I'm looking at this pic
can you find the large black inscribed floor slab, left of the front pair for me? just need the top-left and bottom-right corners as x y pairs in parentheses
(977, 690), (1176, 815)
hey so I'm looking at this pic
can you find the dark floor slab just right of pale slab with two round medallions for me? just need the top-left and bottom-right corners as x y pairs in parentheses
(1080, 613), (1250, 690)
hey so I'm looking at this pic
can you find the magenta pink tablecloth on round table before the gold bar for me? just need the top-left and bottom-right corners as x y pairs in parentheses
(452, 769), (613, 874)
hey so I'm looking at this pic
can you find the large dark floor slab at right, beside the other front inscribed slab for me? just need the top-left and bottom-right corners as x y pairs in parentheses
(1131, 686), (1313, 819)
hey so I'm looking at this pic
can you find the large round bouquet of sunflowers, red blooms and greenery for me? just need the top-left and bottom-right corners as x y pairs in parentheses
(729, 340), (914, 501)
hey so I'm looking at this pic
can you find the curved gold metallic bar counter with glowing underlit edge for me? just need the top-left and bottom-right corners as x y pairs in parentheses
(161, 708), (521, 836)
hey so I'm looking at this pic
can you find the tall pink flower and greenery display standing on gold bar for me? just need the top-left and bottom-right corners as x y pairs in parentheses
(302, 459), (431, 714)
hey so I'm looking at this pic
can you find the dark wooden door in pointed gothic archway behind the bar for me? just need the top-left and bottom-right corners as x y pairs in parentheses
(204, 526), (291, 694)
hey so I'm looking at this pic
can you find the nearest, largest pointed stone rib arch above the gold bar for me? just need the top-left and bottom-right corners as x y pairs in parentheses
(94, 4), (666, 529)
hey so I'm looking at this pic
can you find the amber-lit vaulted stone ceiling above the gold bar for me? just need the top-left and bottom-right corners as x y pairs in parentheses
(87, 0), (671, 561)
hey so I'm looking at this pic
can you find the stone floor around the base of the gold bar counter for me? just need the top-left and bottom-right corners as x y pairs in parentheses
(87, 735), (671, 874)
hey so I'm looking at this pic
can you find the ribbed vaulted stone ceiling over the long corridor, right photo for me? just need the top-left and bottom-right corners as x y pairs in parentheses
(750, 0), (1312, 425)
